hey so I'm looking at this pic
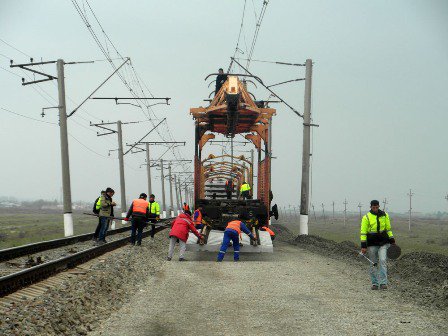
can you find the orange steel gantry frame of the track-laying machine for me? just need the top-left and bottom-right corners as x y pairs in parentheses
(190, 75), (276, 218)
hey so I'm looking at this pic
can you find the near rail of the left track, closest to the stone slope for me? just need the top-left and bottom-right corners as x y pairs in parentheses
(0, 218), (172, 297)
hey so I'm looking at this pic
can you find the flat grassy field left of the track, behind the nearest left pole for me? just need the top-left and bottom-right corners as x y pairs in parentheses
(0, 209), (102, 249)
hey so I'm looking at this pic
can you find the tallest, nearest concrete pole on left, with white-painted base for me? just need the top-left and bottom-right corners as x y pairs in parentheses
(10, 58), (75, 237)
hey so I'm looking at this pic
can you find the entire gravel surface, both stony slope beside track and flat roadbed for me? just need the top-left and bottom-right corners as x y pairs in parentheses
(0, 227), (448, 336)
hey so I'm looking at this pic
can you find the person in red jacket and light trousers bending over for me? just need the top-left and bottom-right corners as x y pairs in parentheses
(167, 213), (203, 261)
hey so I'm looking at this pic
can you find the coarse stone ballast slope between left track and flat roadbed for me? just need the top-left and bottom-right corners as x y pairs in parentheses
(0, 231), (166, 336)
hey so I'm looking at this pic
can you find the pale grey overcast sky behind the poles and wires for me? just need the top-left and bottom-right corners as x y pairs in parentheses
(0, 0), (448, 212)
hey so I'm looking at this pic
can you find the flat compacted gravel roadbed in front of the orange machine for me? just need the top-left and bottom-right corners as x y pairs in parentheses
(89, 227), (448, 336)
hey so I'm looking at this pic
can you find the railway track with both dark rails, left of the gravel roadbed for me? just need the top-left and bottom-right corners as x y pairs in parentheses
(0, 218), (171, 298)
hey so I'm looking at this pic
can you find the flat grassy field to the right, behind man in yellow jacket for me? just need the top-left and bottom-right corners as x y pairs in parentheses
(273, 214), (448, 255)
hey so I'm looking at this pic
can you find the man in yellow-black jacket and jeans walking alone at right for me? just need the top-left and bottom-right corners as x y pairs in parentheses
(361, 200), (395, 290)
